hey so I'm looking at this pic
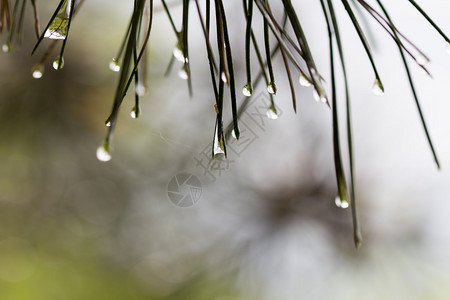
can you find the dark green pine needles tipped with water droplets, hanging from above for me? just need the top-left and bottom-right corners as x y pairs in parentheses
(0, 0), (450, 246)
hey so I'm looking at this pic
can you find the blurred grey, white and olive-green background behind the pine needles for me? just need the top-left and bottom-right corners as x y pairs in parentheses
(0, 0), (450, 300)
